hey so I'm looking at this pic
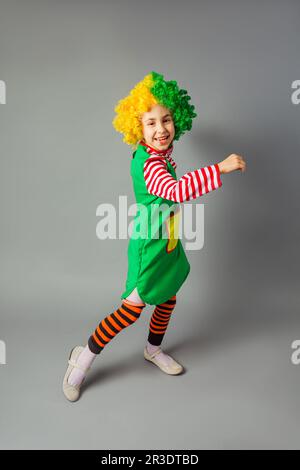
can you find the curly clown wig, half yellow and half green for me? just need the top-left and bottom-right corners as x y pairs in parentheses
(113, 72), (197, 148)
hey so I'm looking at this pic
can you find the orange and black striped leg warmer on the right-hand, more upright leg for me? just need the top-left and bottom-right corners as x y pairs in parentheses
(148, 295), (176, 346)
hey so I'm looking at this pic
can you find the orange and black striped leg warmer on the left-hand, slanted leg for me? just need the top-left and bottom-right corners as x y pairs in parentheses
(88, 299), (145, 354)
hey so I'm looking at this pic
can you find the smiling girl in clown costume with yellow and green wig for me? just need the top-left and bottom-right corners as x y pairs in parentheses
(63, 72), (246, 401)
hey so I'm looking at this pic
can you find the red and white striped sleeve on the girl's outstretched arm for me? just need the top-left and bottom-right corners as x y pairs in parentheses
(144, 156), (222, 202)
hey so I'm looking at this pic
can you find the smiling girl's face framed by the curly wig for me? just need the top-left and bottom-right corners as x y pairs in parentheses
(141, 104), (175, 150)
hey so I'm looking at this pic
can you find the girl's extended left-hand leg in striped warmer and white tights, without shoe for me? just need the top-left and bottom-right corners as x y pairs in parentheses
(68, 293), (146, 385)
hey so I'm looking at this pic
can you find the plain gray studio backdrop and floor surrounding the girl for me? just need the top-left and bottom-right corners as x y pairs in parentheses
(0, 0), (300, 449)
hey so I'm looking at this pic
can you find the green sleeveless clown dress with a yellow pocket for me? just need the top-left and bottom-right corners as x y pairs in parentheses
(121, 144), (190, 305)
